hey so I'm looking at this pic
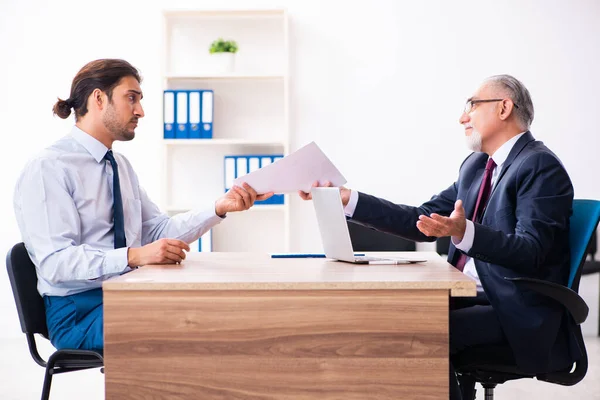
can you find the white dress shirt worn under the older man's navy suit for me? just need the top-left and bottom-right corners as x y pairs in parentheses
(344, 132), (525, 288)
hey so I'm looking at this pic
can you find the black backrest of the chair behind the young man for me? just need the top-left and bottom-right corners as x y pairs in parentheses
(6, 243), (48, 338)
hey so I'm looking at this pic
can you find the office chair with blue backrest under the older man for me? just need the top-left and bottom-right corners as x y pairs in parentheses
(453, 200), (600, 400)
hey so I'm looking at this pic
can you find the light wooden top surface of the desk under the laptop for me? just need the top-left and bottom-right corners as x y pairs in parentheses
(103, 252), (476, 296)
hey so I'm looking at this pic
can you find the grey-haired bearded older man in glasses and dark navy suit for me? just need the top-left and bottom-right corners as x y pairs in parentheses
(300, 75), (581, 399)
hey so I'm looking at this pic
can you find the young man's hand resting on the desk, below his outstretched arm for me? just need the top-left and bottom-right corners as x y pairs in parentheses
(127, 239), (190, 267)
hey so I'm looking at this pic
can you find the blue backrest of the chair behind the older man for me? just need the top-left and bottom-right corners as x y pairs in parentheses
(568, 199), (600, 292)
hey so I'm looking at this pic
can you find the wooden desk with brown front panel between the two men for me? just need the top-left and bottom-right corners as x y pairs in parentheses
(103, 253), (476, 400)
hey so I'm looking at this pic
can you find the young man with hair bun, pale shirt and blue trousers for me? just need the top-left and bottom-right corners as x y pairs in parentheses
(14, 59), (272, 350)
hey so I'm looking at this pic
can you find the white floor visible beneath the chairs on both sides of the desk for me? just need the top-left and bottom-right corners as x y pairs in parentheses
(0, 276), (600, 400)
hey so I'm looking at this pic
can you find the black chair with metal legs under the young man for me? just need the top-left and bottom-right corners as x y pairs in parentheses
(6, 243), (104, 400)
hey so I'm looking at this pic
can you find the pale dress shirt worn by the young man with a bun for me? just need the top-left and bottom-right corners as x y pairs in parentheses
(14, 126), (222, 296)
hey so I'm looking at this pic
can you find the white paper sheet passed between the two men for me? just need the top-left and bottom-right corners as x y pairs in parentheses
(234, 142), (346, 194)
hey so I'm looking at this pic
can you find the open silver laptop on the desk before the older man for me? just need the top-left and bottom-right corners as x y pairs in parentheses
(311, 187), (427, 264)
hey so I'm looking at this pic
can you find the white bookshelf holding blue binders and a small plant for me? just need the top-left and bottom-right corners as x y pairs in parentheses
(160, 10), (290, 252)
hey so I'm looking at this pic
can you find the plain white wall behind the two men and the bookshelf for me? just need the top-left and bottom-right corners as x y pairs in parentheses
(0, 0), (600, 337)
